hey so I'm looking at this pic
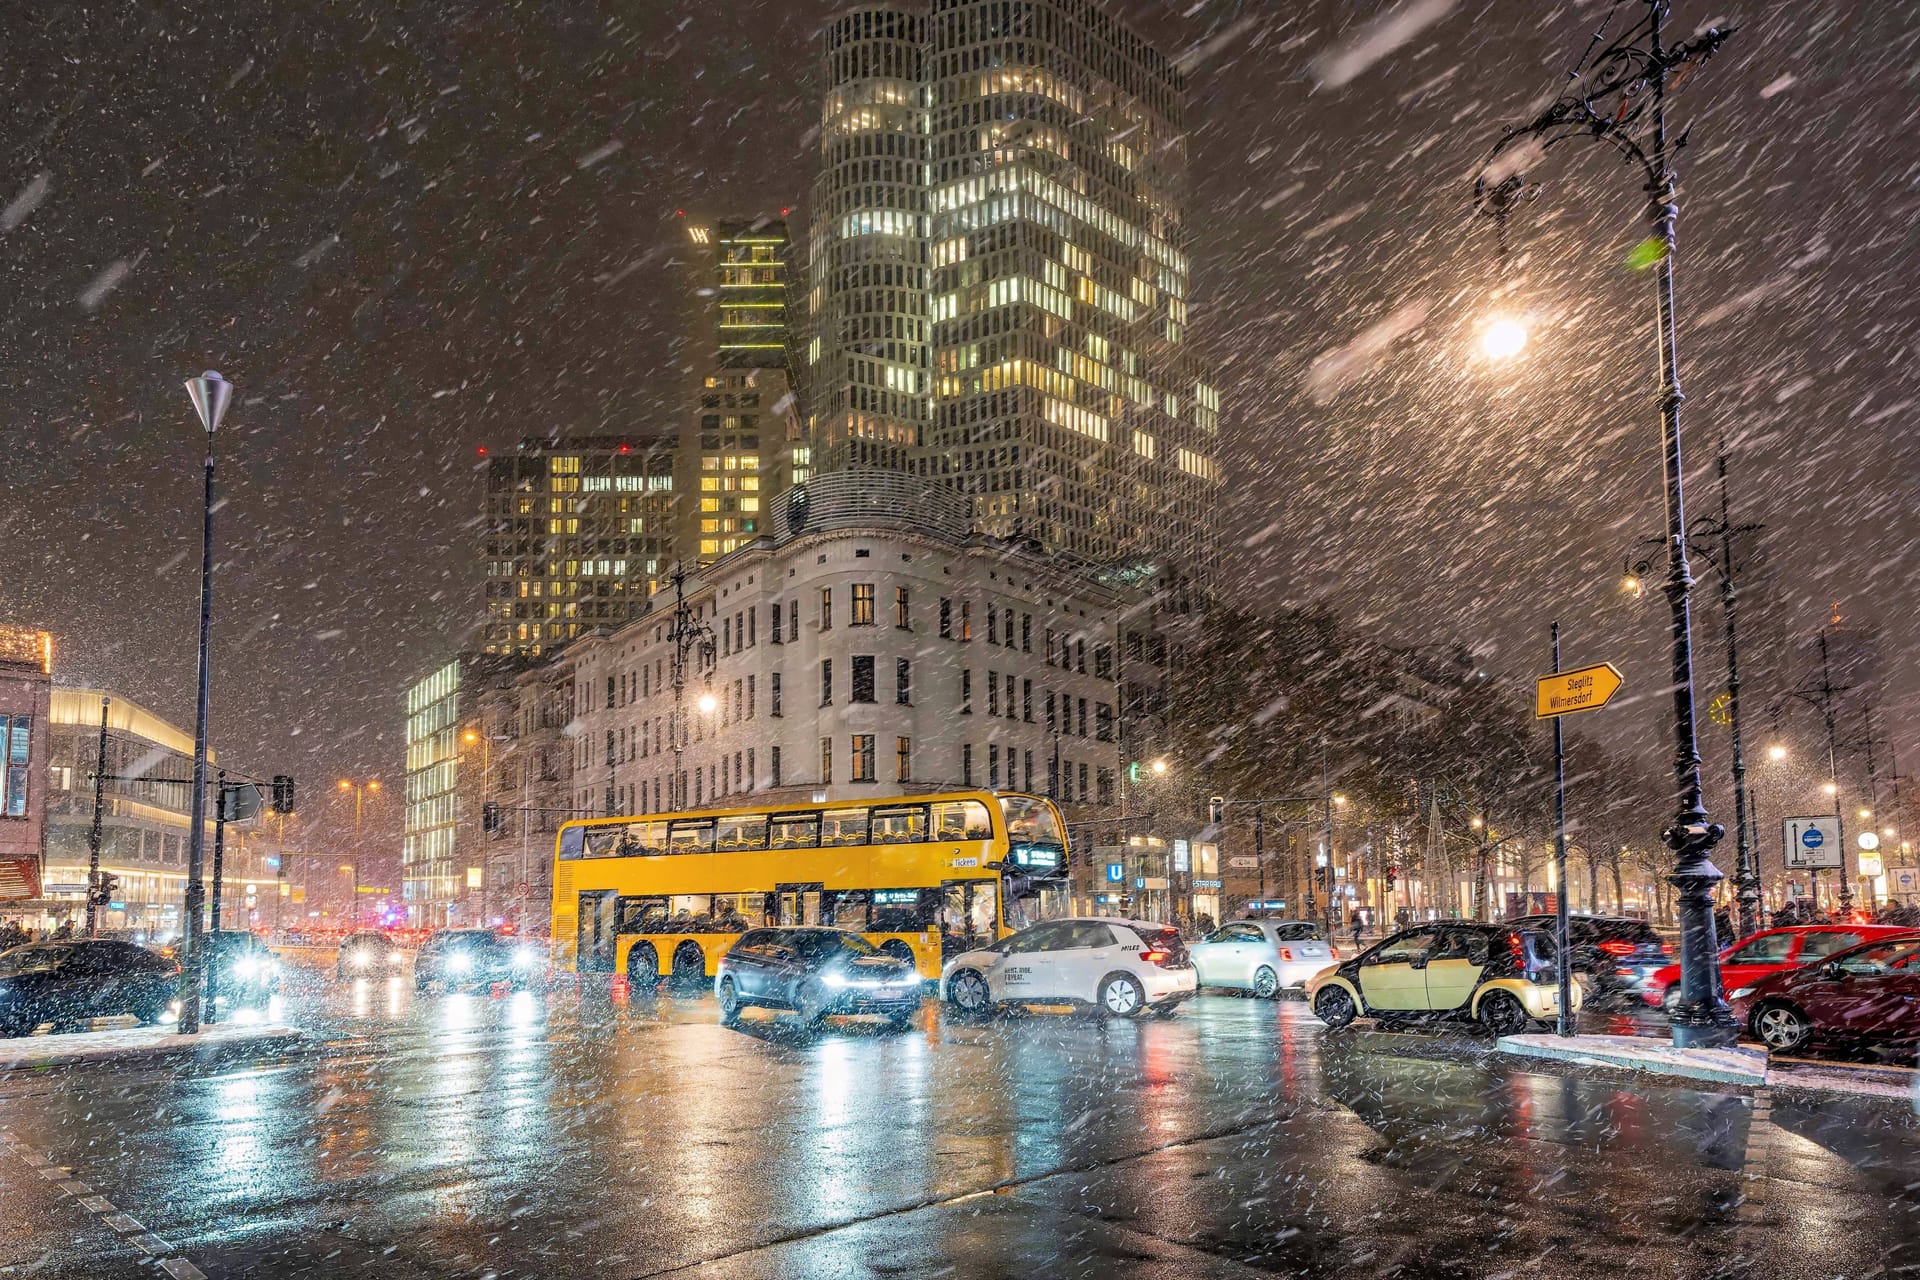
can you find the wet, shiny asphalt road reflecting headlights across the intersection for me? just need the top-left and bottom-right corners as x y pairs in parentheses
(0, 959), (1920, 1280)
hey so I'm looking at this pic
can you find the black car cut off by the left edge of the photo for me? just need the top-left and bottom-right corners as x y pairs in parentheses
(0, 938), (180, 1038)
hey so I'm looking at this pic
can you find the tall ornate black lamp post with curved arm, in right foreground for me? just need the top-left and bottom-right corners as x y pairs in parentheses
(1475, 0), (1738, 1048)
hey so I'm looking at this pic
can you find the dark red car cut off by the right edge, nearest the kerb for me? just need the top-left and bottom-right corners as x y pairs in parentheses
(1732, 929), (1920, 1054)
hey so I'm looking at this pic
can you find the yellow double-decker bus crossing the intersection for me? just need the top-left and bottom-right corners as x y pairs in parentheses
(553, 791), (1068, 986)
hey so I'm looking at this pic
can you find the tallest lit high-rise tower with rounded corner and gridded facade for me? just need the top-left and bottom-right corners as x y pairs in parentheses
(804, 0), (1221, 585)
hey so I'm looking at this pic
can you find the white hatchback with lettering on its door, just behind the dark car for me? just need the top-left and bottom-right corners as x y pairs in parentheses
(941, 915), (1194, 1017)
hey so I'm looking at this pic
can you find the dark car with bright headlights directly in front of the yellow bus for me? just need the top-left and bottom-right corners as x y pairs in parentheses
(714, 927), (920, 1027)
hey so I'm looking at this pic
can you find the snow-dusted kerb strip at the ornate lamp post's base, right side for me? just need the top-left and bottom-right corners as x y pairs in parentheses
(1498, 1034), (1920, 1105)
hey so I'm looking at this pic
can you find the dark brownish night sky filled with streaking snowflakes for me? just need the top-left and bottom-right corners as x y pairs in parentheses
(0, 0), (1920, 871)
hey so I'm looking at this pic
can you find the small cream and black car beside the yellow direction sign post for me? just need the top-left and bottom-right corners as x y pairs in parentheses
(1308, 921), (1580, 1036)
